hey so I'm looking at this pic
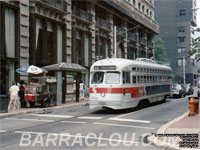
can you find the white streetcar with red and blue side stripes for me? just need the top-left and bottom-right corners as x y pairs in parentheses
(89, 58), (172, 109)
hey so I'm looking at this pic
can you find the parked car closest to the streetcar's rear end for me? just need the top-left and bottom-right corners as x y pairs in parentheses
(171, 84), (186, 98)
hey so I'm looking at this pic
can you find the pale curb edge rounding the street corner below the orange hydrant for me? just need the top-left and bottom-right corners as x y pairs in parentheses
(147, 112), (189, 150)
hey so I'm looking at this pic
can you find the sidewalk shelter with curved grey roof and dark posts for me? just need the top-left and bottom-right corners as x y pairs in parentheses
(43, 62), (87, 105)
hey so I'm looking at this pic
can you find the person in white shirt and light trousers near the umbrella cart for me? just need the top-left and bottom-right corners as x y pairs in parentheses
(8, 81), (19, 109)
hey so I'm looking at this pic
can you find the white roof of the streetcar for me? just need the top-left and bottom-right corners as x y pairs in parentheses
(91, 58), (171, 70)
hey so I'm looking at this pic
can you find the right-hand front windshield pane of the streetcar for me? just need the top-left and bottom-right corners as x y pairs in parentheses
(106, 72), (120, 84)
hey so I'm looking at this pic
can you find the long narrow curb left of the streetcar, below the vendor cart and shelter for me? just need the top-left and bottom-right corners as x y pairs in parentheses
(0, 101), (89, 118)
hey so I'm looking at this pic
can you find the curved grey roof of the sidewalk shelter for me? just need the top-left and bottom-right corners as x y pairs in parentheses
(43, 62), (87, 72)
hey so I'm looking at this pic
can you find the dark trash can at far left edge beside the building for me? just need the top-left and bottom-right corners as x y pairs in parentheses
(0, 95), (10, 113)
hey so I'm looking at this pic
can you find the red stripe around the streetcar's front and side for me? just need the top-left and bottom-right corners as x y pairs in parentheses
(90, 87), (145, 98)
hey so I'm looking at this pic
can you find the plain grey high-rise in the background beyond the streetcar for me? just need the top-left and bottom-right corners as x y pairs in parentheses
(155, 0), (199, 84)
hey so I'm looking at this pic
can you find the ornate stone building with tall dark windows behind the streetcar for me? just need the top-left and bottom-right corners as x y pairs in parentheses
(0, 0), (159, 94)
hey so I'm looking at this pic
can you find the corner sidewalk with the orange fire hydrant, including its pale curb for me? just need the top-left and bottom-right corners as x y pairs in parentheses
(148, 108), (200, 150)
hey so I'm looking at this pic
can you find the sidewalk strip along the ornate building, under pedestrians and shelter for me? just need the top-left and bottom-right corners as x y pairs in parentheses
(0, 97), (89, 118)
